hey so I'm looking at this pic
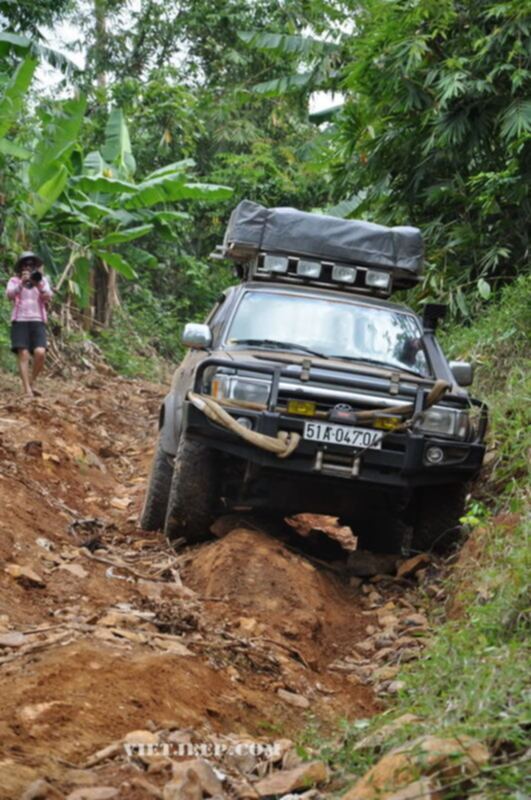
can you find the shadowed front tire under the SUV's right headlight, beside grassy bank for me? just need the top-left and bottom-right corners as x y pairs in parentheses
(411, 483), (467, 554)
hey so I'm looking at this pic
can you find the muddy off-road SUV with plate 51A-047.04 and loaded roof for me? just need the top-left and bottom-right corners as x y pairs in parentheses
(141, 201), (486, 551)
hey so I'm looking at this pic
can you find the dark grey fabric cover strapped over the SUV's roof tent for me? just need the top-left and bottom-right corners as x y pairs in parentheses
(223, 200), (424, 276)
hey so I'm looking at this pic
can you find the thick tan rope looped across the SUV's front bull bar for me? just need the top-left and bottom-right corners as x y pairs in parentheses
(188, 380), (451, 458)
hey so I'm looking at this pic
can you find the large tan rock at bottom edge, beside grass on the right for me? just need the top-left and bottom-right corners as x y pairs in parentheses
(343, 736), (489, 800)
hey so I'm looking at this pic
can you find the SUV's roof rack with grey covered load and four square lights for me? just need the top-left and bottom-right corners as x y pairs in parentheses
(212, 200), (423, 296)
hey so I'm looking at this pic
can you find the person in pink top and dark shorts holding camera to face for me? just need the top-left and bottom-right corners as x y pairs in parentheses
(6, 252), (52, 397)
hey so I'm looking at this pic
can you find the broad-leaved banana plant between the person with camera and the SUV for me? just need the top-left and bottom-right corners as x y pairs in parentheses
(48, 108), (232, 314)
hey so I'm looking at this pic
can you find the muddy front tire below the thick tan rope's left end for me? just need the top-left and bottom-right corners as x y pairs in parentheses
(164, 436), (220, 544)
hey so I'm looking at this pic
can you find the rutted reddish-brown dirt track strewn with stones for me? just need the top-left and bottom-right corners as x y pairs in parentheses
(0, 373), (438, 800)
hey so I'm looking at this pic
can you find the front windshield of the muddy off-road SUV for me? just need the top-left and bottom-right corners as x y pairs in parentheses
(226, 291), (430, 375)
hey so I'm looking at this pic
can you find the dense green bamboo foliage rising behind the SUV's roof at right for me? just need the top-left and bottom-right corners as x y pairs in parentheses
(329, 0), (531, 316)
